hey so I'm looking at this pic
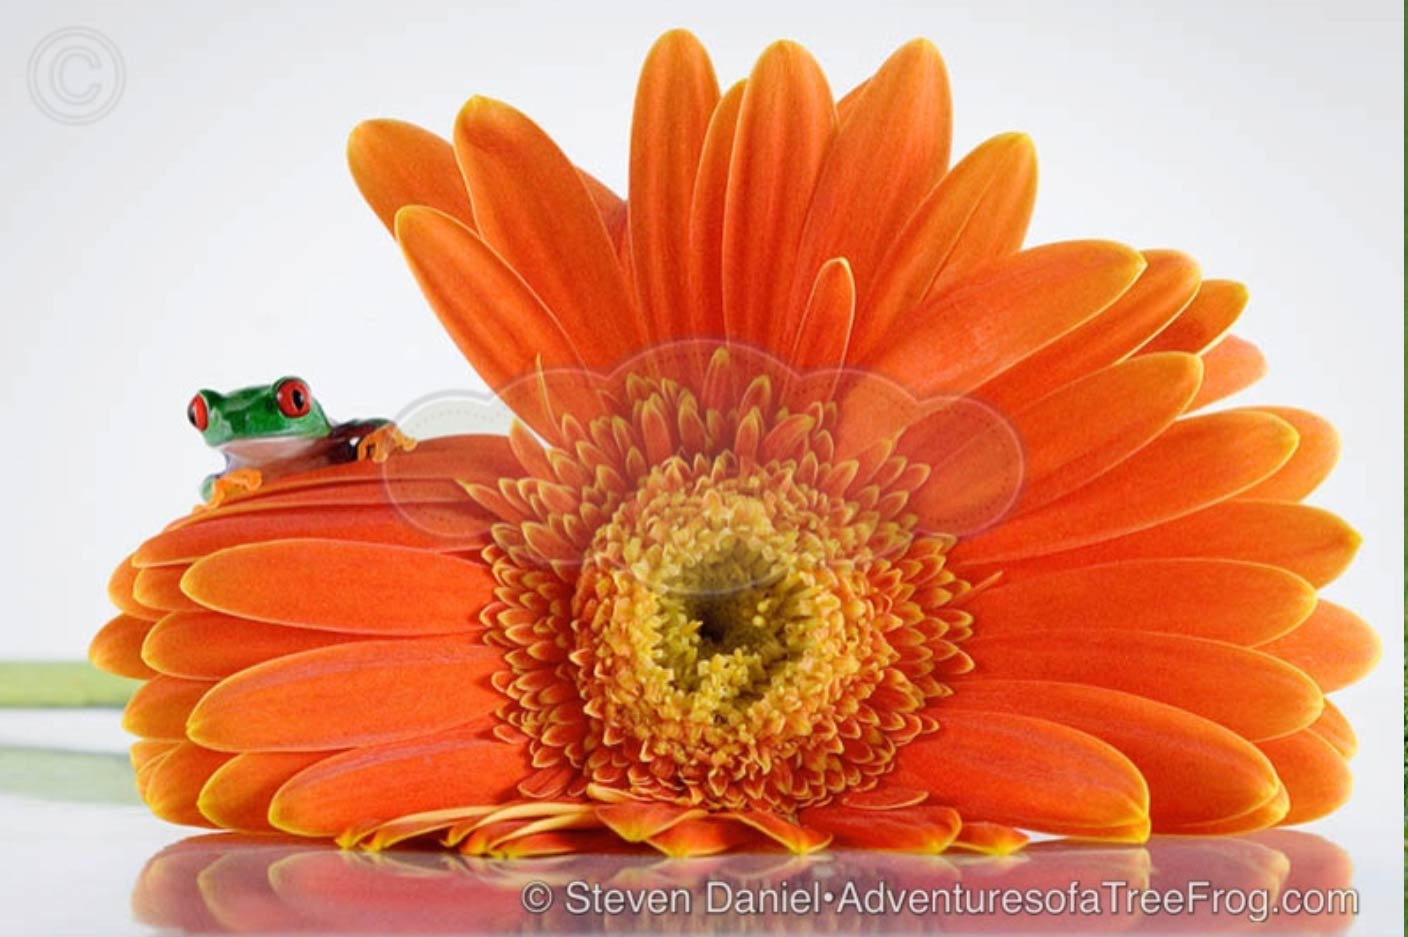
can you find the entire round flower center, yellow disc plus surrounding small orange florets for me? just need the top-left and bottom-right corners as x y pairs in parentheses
(483, 350), (967, 813)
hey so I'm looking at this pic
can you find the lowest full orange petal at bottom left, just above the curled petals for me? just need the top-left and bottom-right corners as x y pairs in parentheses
(269, 726), (529, 837)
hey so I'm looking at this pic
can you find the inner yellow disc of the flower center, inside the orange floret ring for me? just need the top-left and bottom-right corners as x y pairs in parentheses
(577, 455), (895, 789)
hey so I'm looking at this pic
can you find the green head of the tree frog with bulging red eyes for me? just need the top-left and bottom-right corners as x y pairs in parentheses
(186, 378), (331, 448)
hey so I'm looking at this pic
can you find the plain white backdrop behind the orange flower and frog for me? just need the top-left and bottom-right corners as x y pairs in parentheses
(0, 0), (1404, 924)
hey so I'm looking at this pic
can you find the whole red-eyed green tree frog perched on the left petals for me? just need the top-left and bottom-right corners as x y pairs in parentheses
(186, 378), (415, 507)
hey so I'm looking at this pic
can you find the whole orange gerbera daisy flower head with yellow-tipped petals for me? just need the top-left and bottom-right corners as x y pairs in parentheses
(93, 32), (1377, 854)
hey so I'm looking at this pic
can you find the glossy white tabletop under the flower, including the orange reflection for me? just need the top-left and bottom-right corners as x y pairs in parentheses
(0, 710), (1401, 936)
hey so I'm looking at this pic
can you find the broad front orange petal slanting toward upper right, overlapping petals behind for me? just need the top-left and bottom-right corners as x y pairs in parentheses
(862, 241), (1145, 399)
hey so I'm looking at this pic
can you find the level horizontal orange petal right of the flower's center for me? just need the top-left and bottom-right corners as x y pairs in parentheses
(963, 559), (1315, 650)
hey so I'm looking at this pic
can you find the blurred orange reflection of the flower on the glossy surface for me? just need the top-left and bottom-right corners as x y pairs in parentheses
(132, 830), (1353, 934)
